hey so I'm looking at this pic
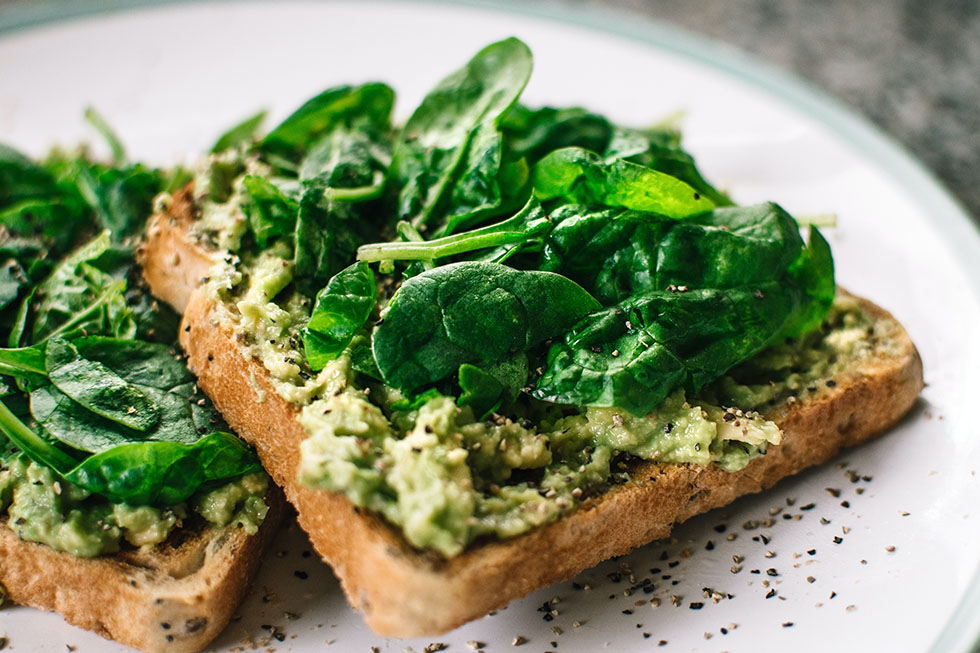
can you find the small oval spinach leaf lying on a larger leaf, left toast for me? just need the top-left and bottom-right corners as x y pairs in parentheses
(45, 338), (160, 431)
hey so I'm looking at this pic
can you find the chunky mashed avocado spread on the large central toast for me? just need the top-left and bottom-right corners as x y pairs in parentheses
(184, 162), (888, 556)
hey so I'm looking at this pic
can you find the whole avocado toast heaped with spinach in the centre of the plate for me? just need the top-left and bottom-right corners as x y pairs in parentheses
(139, 38), (922, 637)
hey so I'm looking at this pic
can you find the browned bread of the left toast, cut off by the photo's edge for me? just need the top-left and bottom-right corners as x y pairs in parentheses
(0, 488), (285, 652)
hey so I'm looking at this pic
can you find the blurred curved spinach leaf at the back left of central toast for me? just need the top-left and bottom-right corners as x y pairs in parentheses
(259, 83), (395, 161)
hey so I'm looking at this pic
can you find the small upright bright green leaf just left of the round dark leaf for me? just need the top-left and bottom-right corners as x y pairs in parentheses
(302, 262), (377, 371)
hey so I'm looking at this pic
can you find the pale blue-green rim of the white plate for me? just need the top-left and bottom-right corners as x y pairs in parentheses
(0, 0), (980, 653)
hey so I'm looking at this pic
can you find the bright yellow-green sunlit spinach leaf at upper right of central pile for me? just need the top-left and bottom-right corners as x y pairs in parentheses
(534, 148), (714, 219)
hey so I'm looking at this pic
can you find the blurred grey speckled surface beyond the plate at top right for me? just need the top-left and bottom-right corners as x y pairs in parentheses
(569, 0), (980, 225)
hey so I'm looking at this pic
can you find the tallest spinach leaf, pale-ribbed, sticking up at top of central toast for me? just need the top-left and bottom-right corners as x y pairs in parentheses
(389, 38), (532, 230)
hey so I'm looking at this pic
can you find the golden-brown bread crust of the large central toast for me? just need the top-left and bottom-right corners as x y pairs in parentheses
(141, 186), (922, 637)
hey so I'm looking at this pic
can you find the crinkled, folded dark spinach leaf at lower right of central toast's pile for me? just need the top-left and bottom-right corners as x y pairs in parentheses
(531, 281), (804, 415)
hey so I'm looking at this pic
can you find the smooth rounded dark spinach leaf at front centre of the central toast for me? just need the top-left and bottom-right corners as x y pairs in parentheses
(372, 262), (598, 392)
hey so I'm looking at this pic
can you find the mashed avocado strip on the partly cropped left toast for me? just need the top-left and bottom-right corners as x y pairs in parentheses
(0, 456), (269, 558)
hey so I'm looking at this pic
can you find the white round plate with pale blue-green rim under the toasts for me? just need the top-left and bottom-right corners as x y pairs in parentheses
(0, 2), (980, 652)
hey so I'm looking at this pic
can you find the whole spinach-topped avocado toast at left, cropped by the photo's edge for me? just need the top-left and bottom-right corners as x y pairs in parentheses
(0, 130), (283, 651)
